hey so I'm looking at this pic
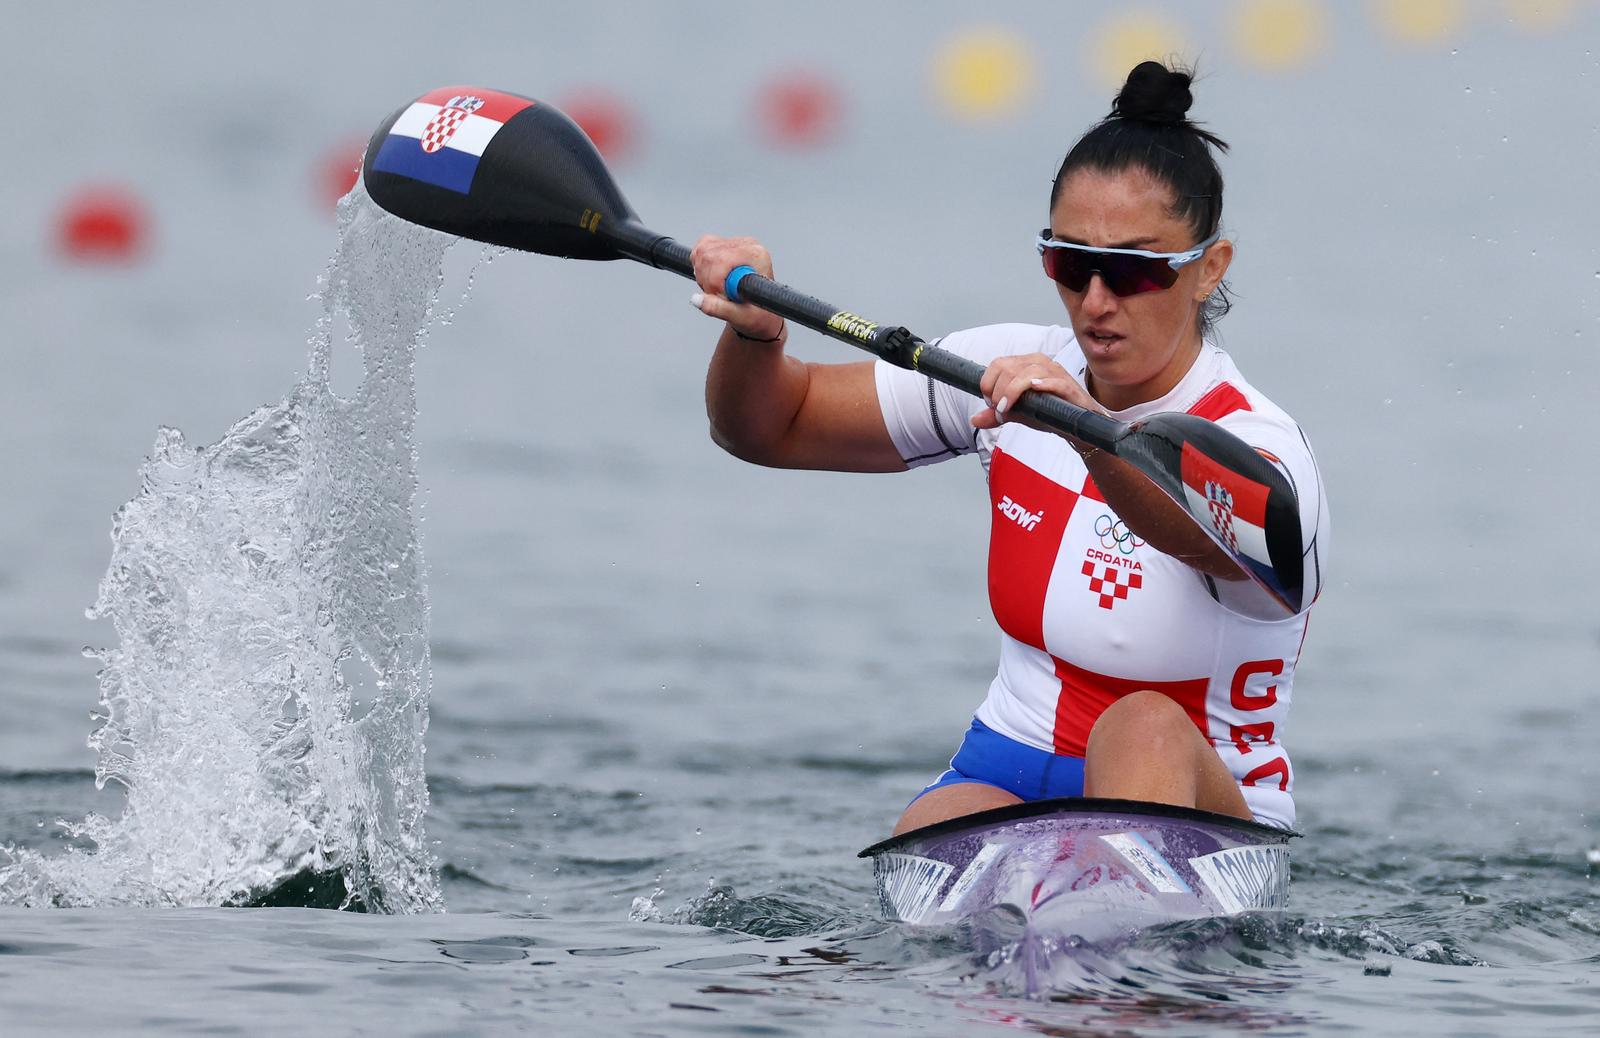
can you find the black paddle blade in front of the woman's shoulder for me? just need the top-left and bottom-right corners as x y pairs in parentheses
(1117, 414), (1306, 613)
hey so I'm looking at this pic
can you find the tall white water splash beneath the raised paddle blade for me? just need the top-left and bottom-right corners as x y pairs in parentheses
(0, 186), (451, 912)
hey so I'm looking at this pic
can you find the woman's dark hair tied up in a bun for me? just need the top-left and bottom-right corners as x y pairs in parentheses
(1050, 61), (1230, 329)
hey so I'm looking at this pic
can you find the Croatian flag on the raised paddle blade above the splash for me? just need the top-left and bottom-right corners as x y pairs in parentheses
(373, 86), (533, 195)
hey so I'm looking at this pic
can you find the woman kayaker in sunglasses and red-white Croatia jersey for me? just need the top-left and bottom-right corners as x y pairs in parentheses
(693, 62), (1328, 832)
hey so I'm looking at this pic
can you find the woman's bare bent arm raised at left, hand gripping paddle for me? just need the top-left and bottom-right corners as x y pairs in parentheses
(691, 235), (906, 472)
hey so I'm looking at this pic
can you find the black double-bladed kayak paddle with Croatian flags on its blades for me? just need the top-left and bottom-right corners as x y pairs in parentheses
(362, 86), (1304, 613)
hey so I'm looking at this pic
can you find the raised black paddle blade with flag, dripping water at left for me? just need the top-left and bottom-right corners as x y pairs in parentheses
(362, 86), (637, 259)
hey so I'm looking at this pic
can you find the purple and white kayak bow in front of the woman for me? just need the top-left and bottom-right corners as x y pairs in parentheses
(861, 796), (1299, 988)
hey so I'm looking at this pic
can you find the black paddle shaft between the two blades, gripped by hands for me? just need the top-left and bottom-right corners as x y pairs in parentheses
(600, 224), (1128, 454)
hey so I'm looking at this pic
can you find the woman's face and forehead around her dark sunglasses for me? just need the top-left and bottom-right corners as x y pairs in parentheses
(1050, 168), (1234, 411)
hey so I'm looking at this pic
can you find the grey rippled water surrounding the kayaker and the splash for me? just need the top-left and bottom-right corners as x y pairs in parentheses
(0, 5), (1600, 1035)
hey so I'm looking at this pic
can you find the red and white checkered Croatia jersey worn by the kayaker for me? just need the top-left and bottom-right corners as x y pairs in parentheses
(877, 325), (1328, 827)
